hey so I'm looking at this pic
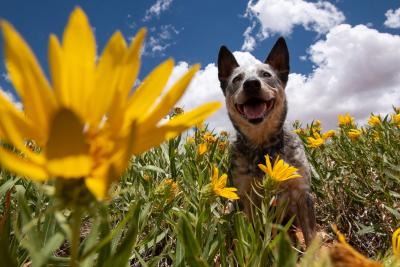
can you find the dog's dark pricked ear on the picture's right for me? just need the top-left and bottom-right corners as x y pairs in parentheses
(265, 37), (290, 85)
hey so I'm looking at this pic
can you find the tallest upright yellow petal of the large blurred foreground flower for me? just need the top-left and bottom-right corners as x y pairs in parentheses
(60, 8), (96, 118)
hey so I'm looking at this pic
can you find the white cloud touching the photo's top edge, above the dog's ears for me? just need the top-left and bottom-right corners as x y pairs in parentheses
(242, 0), (345, 51)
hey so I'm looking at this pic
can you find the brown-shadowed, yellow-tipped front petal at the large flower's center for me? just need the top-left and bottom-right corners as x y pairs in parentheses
(45, 109), (92, 178)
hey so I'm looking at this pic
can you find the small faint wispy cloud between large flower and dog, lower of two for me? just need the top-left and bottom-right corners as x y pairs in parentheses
(144, 24), (179, 56)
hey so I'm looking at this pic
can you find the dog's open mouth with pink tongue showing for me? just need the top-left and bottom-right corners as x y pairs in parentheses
(236, 98), (275, 123)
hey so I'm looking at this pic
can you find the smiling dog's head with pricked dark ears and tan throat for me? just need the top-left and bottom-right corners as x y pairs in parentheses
(218, 37), (289, 143)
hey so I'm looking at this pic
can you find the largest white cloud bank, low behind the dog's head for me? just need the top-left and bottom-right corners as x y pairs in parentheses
(171, 24), (400, 133)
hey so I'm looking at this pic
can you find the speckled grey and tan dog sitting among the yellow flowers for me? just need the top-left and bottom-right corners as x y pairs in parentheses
(218, 37), (316, 246)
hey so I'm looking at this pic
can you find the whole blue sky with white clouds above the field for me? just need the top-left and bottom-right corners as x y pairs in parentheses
(0, 0), (400, 130)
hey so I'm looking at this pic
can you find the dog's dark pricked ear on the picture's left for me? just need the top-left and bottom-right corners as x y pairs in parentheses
(218, 45), (239, 94)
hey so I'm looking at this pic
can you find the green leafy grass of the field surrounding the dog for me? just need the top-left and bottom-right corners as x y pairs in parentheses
(0, 110), (400, 267)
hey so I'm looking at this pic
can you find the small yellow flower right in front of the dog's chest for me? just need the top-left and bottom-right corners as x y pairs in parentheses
(258, 155), (301, 182)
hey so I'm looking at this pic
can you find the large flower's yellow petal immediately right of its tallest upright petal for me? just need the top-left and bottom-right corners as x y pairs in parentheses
(88, 32), (126, 124)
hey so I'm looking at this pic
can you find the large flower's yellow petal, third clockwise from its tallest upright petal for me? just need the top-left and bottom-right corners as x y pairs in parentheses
(127, 59), (174, 122)
